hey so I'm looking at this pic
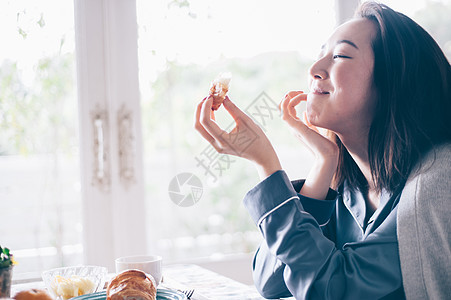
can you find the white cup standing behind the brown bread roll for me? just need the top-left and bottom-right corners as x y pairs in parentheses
(115, 255), (163, 286)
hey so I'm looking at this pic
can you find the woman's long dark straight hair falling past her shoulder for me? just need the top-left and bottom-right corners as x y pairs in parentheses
(333, 2), (451, 193)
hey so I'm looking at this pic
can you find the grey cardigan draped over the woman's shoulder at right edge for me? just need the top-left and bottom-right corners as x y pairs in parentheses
(398, 144), (451, 299)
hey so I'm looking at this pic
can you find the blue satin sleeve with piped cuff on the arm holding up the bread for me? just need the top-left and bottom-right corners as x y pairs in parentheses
(244, 171), (401, 299)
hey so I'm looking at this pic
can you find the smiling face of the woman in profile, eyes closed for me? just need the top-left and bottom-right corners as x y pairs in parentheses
(307, 19), (376, 135)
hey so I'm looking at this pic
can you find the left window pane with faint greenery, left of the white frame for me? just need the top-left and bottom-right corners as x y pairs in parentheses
(0, 0), (82, 274)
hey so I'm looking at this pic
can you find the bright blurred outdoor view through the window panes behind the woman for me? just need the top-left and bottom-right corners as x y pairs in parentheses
(0, 0), (451, 282)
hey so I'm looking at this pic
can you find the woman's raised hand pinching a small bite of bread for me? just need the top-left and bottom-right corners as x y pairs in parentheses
(194, 96), (281, 178)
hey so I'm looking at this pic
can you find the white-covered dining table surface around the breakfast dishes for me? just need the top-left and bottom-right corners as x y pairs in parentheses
(11, 264), (292, 300)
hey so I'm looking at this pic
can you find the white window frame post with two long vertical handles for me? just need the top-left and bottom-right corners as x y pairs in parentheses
(74, 0), (147, 271)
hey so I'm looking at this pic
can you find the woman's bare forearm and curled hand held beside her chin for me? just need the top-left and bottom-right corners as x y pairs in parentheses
(279, 91), (339, 199)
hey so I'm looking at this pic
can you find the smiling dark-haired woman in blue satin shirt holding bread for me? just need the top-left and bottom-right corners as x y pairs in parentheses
(195, 2), (451, 299)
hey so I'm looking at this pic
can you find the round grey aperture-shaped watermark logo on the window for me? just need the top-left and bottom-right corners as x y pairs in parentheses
(168, 173), (203, 207)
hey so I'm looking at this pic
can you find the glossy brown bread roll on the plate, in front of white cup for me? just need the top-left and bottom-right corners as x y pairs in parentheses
(106, 270), (157, 300)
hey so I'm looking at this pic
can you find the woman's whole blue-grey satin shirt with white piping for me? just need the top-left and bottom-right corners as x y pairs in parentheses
(244, 171), (405, 299)
